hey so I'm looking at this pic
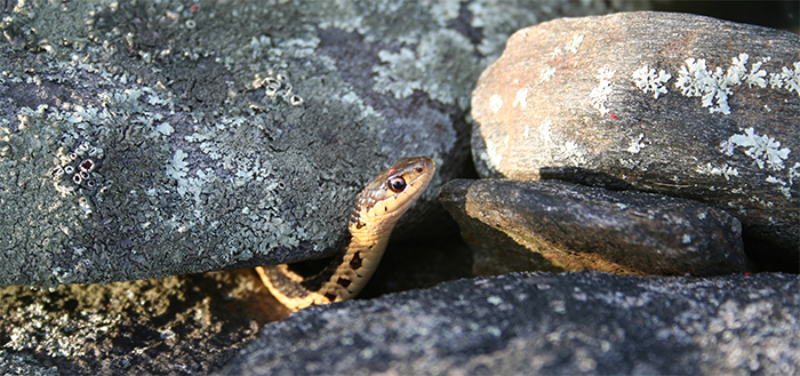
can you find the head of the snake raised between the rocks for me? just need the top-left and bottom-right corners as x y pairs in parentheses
(350, 157), (436, 229)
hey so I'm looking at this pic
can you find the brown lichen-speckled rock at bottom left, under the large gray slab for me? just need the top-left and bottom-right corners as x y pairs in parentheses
(0, 270), (289, 376)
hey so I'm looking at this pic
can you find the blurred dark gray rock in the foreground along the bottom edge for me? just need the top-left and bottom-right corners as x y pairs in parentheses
(217, 272), (800, 375)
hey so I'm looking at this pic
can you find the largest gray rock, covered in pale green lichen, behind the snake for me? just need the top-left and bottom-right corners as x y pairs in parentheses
(0, 0), (620, 286)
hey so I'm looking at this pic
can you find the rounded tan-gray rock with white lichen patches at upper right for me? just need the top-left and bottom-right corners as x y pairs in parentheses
(472, 12), (800, 265)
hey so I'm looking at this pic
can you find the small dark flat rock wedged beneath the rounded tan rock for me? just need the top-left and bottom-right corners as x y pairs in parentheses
(439, 179), (747, 276)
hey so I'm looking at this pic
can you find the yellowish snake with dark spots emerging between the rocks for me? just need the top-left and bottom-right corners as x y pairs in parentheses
(256, 157), (436, 312)
